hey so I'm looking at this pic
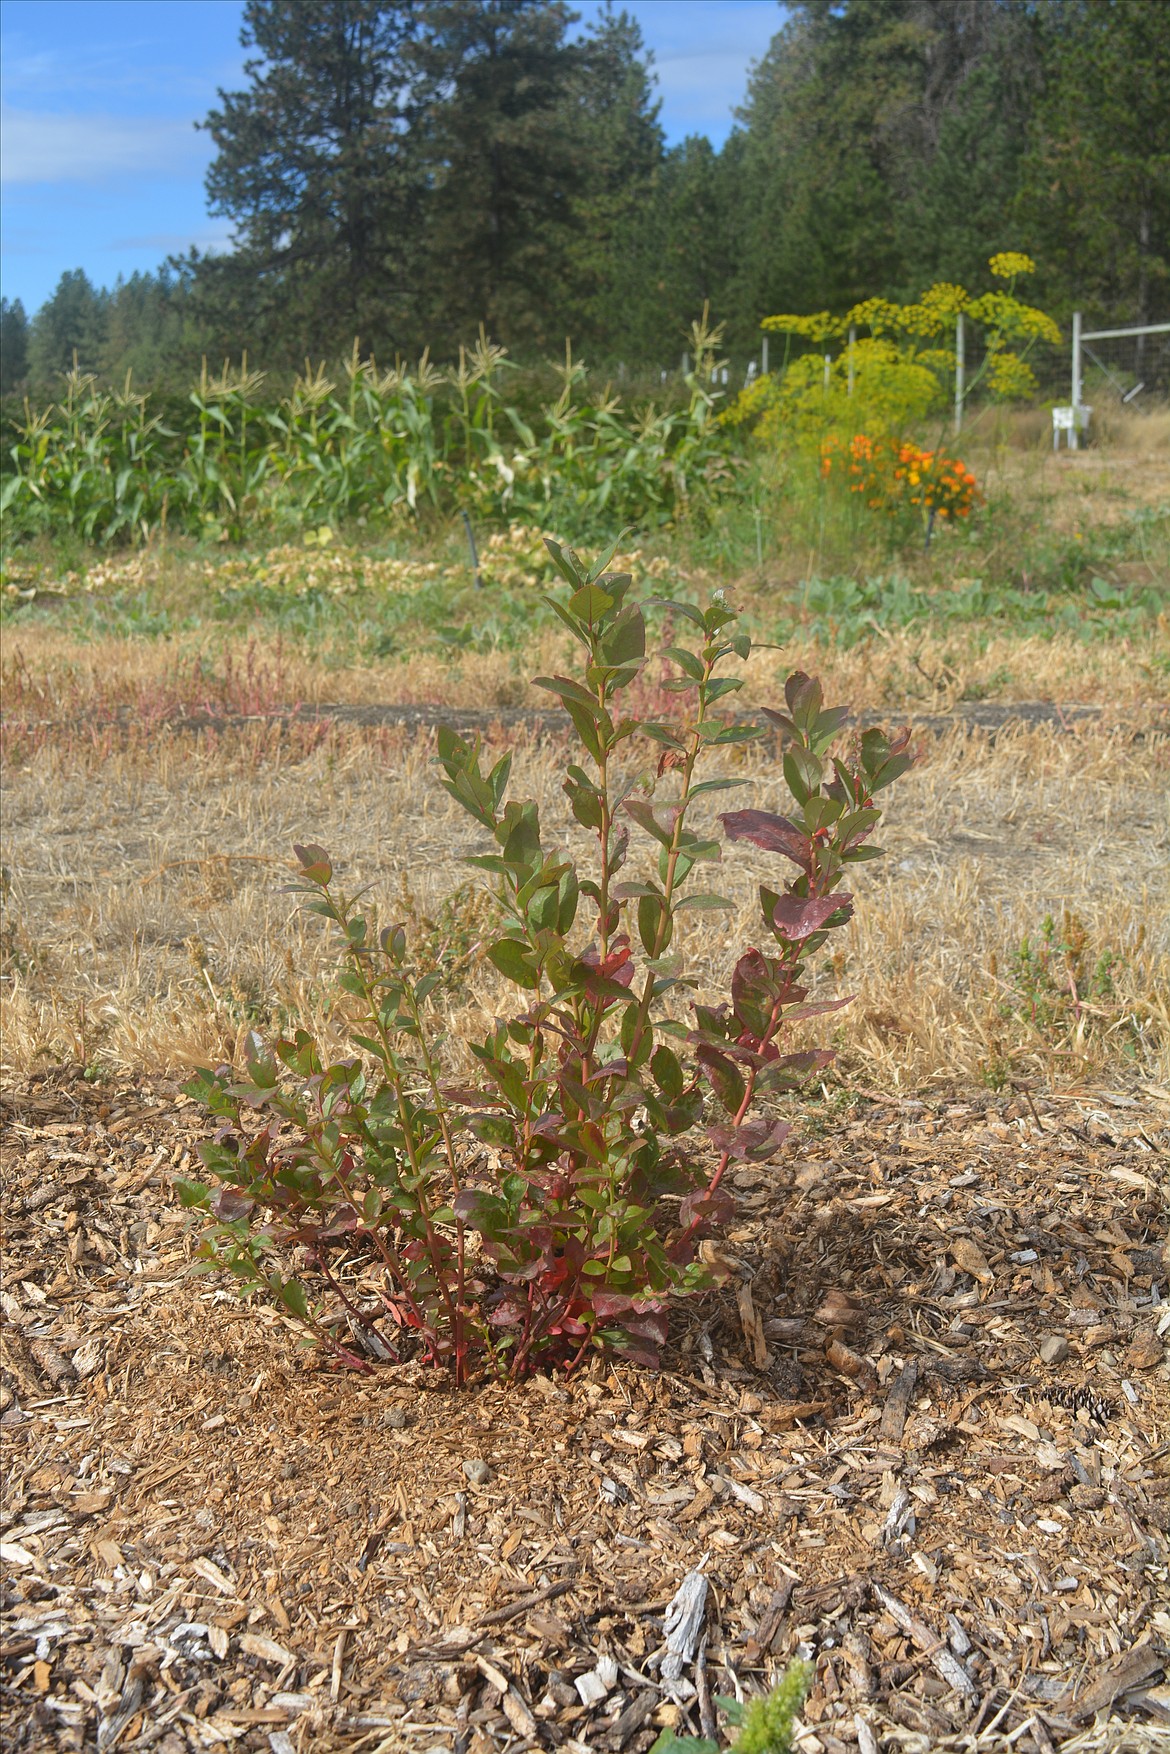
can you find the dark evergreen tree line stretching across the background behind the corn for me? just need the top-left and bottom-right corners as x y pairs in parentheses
(0, 0), (1170, 391)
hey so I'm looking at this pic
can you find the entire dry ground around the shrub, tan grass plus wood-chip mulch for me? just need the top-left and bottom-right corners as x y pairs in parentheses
(0, 417), (1170, 1754)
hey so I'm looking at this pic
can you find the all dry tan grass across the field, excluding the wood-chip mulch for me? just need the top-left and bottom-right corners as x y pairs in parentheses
(0, 424), (1170, 1087)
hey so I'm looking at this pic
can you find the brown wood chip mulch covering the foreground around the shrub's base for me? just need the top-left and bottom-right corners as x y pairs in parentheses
(0, 1073), (1170, 1754)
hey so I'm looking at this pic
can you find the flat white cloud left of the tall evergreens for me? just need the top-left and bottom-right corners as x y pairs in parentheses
(0, 109), (207, 186)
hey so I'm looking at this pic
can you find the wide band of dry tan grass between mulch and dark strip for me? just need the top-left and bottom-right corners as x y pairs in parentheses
(4, 728), (1170, 1089)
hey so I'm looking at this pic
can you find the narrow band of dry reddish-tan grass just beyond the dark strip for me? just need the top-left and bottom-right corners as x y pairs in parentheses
(4, 613), (1170, 743)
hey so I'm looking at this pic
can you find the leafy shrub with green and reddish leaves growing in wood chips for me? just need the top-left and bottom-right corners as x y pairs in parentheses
(181, 542), (912, 1382)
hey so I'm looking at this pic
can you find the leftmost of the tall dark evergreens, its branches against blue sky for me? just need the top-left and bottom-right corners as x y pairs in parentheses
(196, 0), (428, 360)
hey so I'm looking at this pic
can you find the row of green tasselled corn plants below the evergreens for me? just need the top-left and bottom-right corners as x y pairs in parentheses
(0, 317), (733, 540)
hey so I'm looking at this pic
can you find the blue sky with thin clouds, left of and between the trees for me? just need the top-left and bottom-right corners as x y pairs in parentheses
(0, 0), (782, 314)
